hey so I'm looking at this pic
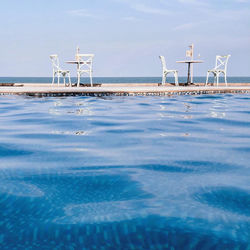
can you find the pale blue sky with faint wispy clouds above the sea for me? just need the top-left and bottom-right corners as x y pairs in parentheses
(0, 0), (250, 77)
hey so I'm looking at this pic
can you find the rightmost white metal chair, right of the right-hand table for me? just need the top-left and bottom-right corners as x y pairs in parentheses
(206, 55), (231, 86)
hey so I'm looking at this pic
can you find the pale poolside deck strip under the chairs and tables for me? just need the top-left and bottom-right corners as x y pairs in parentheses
(0, 83), (250, 96)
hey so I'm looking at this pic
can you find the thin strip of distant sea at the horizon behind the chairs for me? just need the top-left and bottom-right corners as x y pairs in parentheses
(0, 76), (250, 83)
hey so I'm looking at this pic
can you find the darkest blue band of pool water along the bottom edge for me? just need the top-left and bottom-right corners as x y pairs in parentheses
(1, 215), (248, 250)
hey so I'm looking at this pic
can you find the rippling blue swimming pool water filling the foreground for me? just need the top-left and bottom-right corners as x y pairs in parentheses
(0, 91), (250, 250)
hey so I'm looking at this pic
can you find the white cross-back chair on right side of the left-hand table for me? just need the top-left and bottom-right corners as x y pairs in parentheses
(76, 54), (94, 87)
